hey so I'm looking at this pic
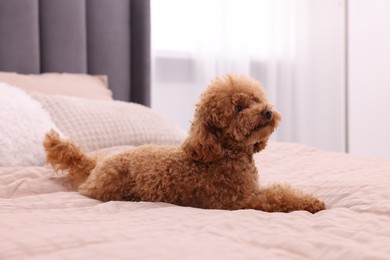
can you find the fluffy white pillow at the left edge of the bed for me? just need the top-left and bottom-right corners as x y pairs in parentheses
(0, 83), (62, 166)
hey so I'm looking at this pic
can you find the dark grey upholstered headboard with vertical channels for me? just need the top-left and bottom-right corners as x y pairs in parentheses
(0, 0), (150, 105)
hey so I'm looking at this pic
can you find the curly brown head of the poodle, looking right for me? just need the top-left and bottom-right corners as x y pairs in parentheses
(183, 75), (281, 162)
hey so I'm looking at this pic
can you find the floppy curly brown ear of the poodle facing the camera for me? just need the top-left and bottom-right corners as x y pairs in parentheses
(182, 120), (223, 162)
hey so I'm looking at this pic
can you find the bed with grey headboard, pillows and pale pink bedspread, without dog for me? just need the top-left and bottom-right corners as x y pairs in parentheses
(0, 0), (390, 259)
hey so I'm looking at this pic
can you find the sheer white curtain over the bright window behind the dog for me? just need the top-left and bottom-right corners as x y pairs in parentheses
(151, 0), (345, 151)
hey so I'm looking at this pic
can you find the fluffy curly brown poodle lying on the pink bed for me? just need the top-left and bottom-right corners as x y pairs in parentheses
(44, 75), (325, 213)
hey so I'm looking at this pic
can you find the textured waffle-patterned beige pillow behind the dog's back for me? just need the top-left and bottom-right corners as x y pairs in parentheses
(33, 93), (186, 150)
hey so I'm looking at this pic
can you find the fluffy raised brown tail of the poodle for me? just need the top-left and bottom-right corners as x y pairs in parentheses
(43, 130), (96, 189)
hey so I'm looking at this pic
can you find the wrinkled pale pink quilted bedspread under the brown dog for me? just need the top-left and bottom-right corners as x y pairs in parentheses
(0, 143), (390, 259)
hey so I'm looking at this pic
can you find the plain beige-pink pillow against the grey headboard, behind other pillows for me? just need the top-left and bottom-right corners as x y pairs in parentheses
(0, 72), (112, 100)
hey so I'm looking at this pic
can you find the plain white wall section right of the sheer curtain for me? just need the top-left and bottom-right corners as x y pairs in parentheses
(348, 0), (390, 156)
